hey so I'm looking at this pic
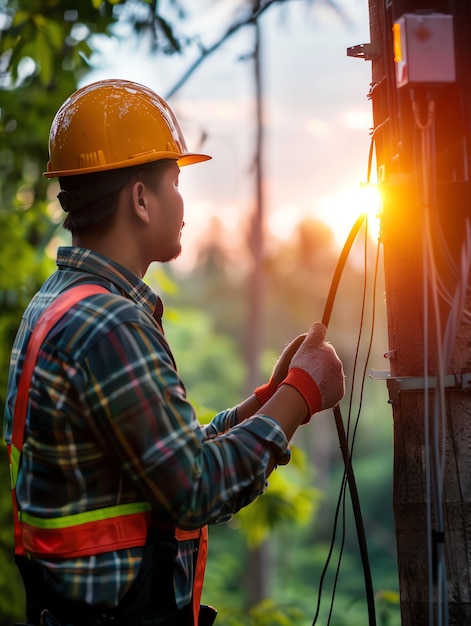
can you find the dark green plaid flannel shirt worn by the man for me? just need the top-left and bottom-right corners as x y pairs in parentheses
(4, 247), (288, 607)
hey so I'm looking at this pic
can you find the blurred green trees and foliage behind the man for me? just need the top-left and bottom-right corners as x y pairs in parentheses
(0, 0), (400, 626)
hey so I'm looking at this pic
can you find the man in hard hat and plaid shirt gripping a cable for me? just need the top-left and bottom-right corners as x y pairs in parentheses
(5, 80), (344, 626)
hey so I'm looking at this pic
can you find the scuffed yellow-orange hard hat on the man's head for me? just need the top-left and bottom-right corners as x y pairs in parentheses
(44, 79), (211, 178)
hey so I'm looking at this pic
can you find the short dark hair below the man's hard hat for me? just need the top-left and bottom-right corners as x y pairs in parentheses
(58, 159), (173, 235)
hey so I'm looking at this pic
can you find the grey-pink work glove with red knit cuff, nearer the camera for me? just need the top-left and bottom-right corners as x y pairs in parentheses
(282, 323), (345, 424)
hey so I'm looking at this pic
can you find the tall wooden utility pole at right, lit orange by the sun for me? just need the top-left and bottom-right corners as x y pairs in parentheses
(356, 0), (471, 626)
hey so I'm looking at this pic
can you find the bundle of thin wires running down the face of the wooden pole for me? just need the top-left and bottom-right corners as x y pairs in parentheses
(411, 92), (471, 626)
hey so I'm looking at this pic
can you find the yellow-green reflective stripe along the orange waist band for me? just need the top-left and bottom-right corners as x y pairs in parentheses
(18, 502), (152, 528)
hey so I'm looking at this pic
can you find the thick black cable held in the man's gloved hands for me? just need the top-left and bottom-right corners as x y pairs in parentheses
(313, 215), (376, 626)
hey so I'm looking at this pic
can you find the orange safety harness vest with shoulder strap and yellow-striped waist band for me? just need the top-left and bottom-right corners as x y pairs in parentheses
(8, 284), (208, 626)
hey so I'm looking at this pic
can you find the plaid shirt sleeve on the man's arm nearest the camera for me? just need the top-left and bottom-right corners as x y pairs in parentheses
(78, 312), (289, 528)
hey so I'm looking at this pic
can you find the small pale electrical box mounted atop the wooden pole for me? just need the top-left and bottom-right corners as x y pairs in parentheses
(393, 13), (456, 87)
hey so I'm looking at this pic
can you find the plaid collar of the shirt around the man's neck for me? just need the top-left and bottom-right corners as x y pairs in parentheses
(57, 246), (163, 315)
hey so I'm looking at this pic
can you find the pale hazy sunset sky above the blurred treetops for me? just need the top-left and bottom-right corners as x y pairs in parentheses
(85, 0), (372, 263)
